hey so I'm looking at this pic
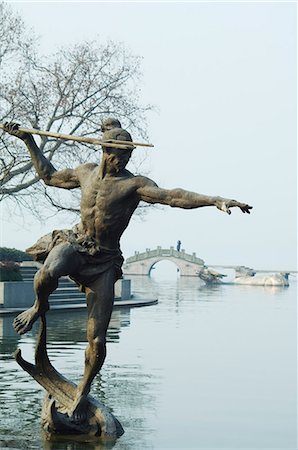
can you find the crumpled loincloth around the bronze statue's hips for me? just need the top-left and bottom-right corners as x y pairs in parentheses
(26, 228), (124, 290)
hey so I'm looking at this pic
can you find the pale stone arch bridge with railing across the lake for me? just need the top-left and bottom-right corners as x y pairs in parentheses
(123, 247), (204, 277)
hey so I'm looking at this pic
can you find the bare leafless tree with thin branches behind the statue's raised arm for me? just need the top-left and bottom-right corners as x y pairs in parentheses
(0, 3), (152, 221)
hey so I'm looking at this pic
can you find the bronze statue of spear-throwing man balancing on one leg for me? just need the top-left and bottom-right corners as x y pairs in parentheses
(4, 122), (252, 422)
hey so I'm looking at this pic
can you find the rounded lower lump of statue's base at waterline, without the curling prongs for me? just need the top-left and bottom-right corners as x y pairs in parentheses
(41, 393), (124, 440)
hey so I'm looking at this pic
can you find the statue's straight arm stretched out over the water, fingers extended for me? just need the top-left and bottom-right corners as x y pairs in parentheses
(138, 185), (252, 214)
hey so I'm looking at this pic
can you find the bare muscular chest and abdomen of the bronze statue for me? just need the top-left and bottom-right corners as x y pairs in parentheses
(77, 164), (145, 249)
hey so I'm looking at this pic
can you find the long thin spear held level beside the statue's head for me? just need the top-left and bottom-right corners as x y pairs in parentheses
(0, 123), (154, 149)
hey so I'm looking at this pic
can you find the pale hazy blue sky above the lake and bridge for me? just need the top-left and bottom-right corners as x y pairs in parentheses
(1, 1), (297, 269)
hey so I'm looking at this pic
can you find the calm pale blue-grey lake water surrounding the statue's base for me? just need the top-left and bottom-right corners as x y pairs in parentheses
(0, 277), (297, 450)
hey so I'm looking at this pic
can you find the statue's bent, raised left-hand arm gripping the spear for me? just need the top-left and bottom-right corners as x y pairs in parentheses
(3, 122), (79, 189)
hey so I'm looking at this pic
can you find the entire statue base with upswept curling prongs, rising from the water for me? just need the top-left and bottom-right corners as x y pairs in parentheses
(15, 316), (124, 440)
